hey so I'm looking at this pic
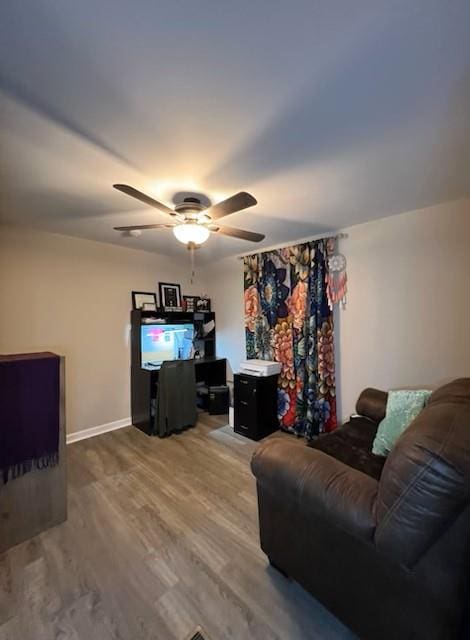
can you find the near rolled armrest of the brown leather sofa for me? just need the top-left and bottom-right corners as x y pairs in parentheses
(251, 438), (378, 539)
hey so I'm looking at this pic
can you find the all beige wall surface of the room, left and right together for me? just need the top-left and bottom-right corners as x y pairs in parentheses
(0, 200), (470, 433)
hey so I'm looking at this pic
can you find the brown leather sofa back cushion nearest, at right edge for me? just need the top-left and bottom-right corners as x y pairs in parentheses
(375, 378), (470, 567)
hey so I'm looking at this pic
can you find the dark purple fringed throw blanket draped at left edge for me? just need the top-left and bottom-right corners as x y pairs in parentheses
(0, 352), (60, 483)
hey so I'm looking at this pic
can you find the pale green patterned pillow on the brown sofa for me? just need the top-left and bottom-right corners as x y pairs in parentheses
(372, 389), (431, 456)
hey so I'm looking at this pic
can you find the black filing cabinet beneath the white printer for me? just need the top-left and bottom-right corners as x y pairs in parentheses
(234, 373), (279, 440)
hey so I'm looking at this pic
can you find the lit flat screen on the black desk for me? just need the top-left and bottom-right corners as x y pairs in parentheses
(140, 324), (194, 366)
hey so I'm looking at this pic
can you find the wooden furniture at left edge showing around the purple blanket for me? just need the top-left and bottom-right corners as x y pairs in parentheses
(0, 354), (67, 553)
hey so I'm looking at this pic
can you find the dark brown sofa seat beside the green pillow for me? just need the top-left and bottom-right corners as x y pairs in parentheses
(308, 417), (385, 480)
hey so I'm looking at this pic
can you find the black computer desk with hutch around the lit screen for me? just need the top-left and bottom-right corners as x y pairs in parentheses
(131, 309), (227, 435)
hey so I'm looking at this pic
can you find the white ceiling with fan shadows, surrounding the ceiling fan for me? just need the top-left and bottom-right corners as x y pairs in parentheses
(0, 0), (470, 262)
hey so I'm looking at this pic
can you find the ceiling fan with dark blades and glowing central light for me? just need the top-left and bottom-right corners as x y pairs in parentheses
(113, 184), (265, 249)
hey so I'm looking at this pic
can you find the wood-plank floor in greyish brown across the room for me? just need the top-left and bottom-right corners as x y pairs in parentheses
(0, 414), (353, 640)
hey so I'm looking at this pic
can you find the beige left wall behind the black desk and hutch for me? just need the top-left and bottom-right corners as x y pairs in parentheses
(0, 228), (205, 433)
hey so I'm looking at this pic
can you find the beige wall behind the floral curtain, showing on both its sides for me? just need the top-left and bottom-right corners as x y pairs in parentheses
(204, 200), (470, 417)
